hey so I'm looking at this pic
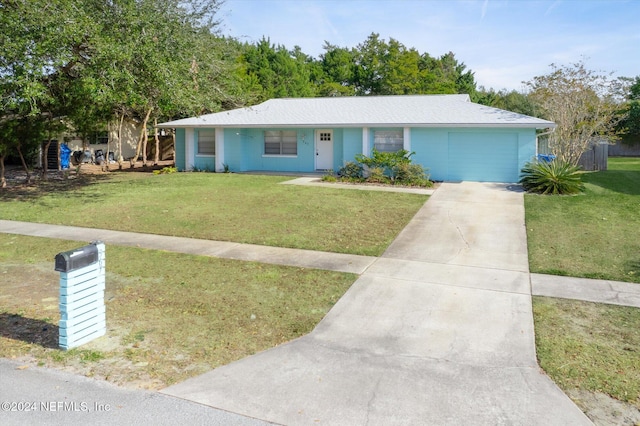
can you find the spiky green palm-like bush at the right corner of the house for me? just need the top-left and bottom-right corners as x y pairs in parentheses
(519, 159), (584, 194)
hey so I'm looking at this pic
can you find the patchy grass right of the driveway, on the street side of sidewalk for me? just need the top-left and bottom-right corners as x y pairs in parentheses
(533, 297), (640, 425)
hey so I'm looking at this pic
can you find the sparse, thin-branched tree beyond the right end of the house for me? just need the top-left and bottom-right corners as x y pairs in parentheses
(525, 61), (619, 165)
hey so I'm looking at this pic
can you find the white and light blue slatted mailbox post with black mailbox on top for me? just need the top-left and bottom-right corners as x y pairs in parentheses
(55, 241), (106, 350)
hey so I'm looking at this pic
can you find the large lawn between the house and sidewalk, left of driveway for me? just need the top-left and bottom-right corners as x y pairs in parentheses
(0, 173), (427, 256)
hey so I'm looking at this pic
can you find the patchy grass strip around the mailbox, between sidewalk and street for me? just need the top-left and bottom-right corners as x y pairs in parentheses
(0, 234), (357, 389)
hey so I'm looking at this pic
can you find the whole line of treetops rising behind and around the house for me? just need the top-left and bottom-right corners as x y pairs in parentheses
(0, 0), (640, 185)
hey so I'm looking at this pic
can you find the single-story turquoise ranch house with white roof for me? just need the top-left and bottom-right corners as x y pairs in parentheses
(158, 95), (555, 182)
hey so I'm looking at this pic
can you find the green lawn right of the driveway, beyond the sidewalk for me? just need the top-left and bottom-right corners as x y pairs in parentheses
(525, 158), (640, 282)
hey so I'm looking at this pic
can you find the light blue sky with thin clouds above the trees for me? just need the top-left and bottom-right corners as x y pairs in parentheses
(218, 0), (640, 91)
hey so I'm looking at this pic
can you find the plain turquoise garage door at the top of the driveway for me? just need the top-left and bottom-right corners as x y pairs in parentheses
(447, 132), (519, 182)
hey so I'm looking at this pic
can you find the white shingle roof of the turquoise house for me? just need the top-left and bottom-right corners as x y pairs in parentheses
(158, 95), (555, 129)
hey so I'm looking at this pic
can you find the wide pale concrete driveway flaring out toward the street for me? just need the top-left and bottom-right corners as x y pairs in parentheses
(162, 182), (591, 425)
